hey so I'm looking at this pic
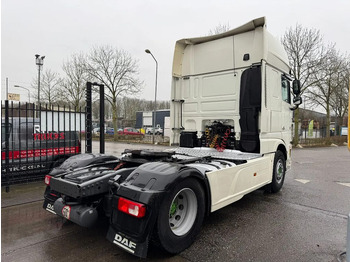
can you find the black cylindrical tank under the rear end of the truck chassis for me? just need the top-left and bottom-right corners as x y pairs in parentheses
(53, 198), (98, 227)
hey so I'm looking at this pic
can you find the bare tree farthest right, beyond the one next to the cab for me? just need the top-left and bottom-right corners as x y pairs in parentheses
(306, 46), (345, 138)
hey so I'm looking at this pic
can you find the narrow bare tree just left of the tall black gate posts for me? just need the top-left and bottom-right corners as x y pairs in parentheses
(61, 54), (87, 111)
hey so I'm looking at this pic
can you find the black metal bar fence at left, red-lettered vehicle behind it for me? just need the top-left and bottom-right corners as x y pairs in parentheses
(1, 100), (86, 186)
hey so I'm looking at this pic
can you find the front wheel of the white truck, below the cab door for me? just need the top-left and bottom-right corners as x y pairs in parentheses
(268, 151), (286, 193)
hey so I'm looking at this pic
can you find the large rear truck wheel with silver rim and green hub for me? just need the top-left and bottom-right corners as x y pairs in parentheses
(156, 179), (205, 254)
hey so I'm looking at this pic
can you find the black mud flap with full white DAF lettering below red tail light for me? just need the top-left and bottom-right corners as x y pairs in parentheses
(107, 226), (148, 258)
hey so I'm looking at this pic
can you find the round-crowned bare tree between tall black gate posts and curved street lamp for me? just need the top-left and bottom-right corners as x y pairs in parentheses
(83, 46), (142, 136)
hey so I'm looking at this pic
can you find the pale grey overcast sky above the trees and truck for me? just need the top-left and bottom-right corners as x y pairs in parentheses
(1, 0), (350, 100)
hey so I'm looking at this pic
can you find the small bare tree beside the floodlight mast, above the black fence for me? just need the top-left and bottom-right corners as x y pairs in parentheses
(32, 69), (62, 107)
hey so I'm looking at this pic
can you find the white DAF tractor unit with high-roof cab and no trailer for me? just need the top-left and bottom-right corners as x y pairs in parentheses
(44, 18), (301, 257)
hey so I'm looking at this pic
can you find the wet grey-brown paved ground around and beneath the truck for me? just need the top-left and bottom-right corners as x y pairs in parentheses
(1, 144), (350, 262)
